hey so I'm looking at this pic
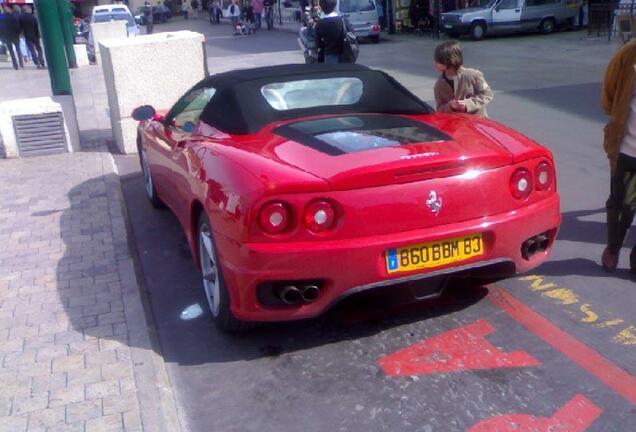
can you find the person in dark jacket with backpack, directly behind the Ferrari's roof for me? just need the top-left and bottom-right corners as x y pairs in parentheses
(316, 0), (353, 63)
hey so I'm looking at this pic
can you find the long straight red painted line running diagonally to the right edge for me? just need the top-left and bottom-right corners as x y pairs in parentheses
(488, 285), (636, 405)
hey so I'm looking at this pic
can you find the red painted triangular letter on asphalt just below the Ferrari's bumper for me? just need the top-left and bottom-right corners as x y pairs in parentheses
(378, 320), (541, 376)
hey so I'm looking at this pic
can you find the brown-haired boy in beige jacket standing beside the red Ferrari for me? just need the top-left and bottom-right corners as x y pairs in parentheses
(434, 40), (494, 117)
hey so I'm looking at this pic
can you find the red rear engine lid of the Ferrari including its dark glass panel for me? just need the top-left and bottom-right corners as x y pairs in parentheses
(274, 114), (513, 190)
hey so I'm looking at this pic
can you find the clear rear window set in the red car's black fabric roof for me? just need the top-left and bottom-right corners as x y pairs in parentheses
(261, 77), (363, 111)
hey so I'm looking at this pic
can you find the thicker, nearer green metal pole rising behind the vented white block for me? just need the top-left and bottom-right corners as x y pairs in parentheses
(35, 0), (72, 96)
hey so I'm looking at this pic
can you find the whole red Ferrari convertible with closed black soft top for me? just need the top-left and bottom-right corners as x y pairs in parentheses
(133, 64), (560, 331)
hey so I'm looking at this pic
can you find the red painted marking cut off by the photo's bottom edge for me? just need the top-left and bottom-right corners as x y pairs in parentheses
(468, 395), (603, 432)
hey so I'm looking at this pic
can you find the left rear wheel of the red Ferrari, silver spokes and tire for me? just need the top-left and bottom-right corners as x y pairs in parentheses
(197, 211), (254, 333)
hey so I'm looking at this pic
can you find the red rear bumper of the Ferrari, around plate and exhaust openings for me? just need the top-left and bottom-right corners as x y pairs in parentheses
(215, 194), (561, 321)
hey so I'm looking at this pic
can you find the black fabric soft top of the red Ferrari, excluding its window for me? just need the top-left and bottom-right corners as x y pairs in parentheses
(194, 64), (433, 134)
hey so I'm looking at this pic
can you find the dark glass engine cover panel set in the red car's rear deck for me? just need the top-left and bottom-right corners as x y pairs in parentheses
(274, 115), (450, 156)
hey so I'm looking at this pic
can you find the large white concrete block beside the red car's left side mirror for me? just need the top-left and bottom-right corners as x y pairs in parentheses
(101, 31), (206, 153)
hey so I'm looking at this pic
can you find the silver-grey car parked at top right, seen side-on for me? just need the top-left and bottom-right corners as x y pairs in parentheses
(441, 0), (581, 40)
